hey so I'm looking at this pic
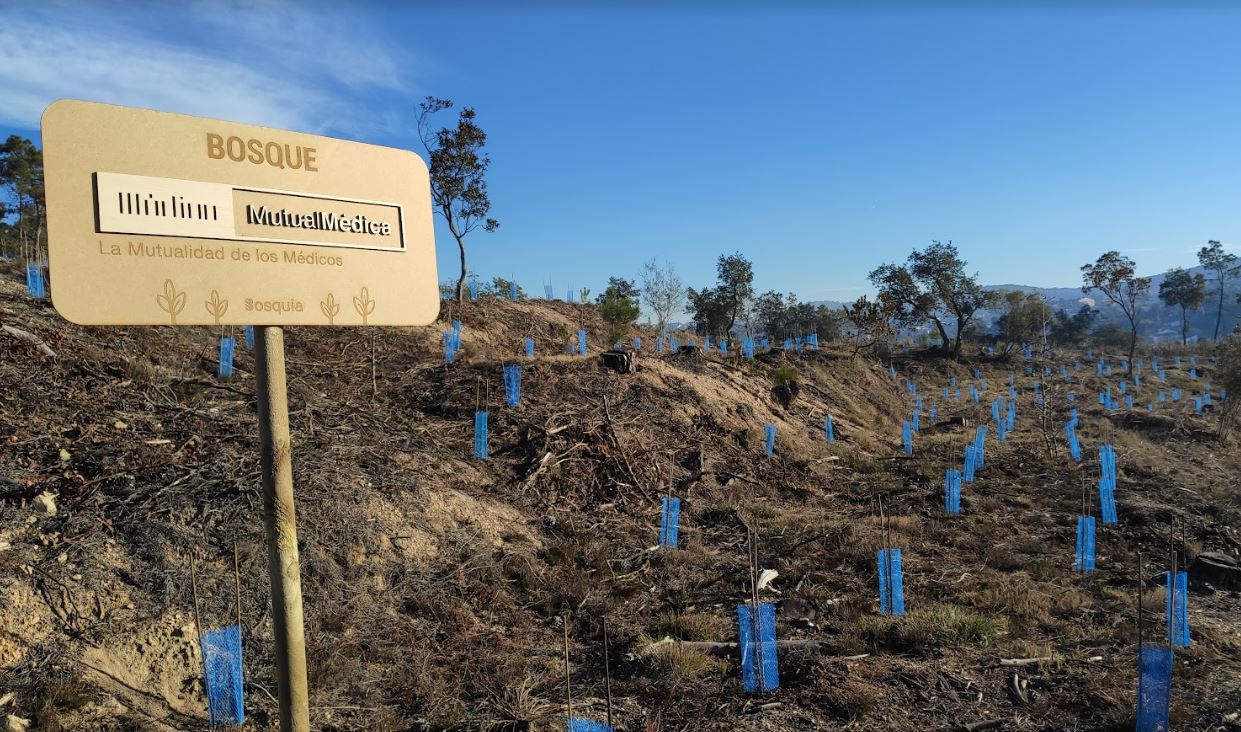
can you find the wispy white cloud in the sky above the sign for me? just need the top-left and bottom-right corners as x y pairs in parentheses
(0, 1), (413, 133)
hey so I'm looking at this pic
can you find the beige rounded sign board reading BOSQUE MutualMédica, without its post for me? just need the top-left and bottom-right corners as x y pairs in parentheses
(42, 100), (439, 325)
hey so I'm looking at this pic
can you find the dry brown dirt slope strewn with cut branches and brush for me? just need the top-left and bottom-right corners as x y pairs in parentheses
(0, 265), (1241, 731)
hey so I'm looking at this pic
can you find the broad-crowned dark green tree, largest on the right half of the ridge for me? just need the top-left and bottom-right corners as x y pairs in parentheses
(870, 241), (992, 359)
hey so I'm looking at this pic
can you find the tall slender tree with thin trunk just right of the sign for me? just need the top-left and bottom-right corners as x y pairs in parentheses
(417, 97), (500, 308)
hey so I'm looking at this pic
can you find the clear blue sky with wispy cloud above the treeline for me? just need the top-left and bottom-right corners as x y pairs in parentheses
(0, 1), (1241, 300)
